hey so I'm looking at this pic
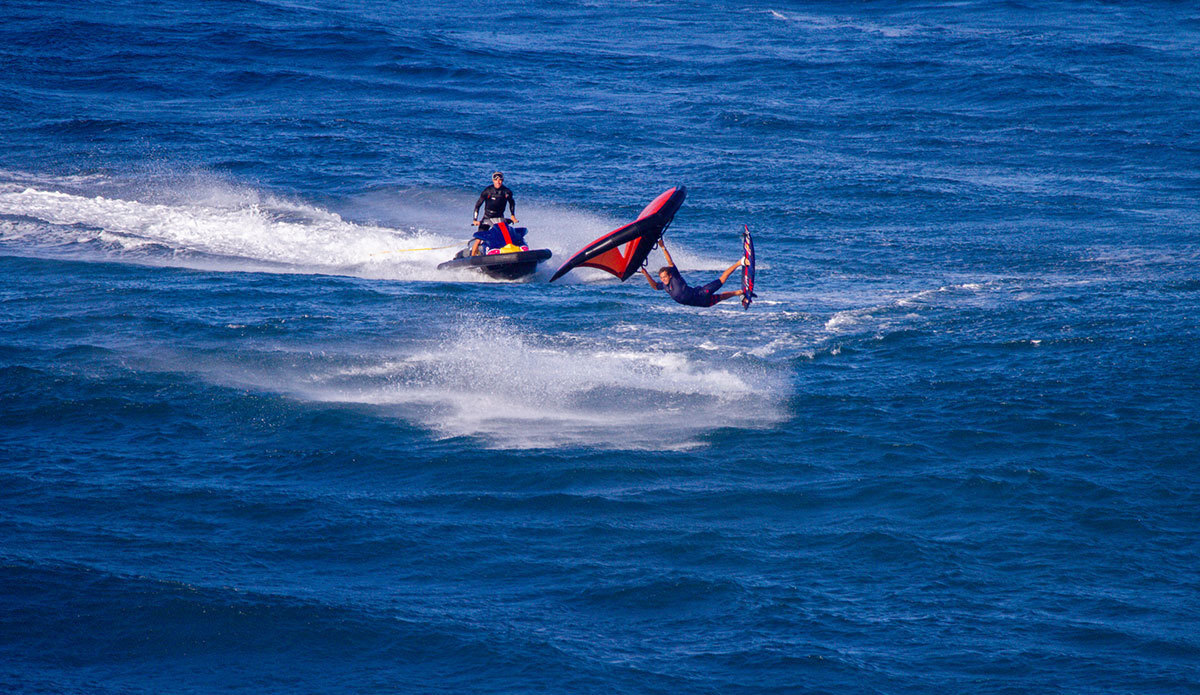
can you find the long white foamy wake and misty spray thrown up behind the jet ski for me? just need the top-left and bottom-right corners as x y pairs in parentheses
(0, 172), (720, 282)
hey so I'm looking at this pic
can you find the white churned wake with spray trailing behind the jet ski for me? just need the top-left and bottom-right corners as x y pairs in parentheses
(0, 174), (713, 281)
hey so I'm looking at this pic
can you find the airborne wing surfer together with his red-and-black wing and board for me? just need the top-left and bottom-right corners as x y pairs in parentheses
(550, 186), (757, 308)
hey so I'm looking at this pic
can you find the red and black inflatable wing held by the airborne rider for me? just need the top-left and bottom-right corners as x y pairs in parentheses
(550, 186), (688, 282)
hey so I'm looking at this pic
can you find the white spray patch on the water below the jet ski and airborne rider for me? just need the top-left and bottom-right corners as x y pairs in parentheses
(126, 314), (787, 450)
